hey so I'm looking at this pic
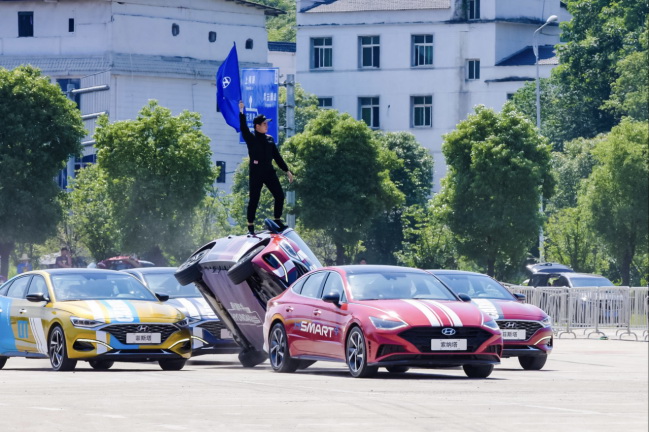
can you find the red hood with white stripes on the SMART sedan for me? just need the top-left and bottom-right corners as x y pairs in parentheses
(354, 299), (484, 327)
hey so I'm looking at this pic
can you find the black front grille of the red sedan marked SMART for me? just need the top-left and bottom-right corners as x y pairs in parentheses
(399, 326), (493, 353)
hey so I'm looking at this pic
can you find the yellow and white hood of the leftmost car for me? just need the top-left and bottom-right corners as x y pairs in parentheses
(54, 299), (184, 323)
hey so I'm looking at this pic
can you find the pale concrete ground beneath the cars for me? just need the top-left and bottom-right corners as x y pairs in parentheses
(0, 339), (649, 432)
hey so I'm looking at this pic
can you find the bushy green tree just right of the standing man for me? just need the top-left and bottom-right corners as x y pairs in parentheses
(284, 110), (404, 264)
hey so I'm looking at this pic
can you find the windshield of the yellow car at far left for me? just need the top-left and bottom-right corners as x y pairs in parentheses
(51, 272), (158, 301)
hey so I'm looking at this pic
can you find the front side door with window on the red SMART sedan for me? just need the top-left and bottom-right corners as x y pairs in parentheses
(313, 271), (349, 359)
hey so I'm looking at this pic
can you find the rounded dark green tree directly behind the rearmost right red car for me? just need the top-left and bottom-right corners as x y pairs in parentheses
(440, 104), (553, 276)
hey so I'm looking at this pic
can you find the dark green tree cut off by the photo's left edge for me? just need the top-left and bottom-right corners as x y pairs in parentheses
(0, 66), (85, 274)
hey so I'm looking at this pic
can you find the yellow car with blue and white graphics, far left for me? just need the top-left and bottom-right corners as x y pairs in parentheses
(0, 269), (192, 371)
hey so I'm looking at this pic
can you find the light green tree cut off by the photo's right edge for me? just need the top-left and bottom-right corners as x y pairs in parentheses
(580, 119), (649, 286)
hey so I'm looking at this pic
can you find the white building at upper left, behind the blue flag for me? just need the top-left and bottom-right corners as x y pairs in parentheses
(0, 0), (282, 192)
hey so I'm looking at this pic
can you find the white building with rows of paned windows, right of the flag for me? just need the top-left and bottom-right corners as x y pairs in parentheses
(296, 0), (568, 190)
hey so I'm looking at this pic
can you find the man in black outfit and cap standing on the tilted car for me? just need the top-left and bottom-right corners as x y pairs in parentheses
(239, 101), (293, 235)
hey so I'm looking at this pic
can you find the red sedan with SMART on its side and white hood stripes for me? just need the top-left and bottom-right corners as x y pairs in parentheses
(264, 265), (503, 378)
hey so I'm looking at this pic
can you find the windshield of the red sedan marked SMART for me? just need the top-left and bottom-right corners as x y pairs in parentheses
(347, 271), (457, 301)
